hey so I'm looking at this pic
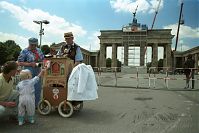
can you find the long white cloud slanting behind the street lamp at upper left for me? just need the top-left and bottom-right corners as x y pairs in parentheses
(0, 1), (87, 42)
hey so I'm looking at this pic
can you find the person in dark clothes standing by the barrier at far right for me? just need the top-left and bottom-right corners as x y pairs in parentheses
(184, 54), (195, 89)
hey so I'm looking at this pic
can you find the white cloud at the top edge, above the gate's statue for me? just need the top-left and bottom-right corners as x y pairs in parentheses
(110, 0), (163, 13)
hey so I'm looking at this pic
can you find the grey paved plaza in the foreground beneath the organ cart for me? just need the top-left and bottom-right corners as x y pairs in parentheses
(0, 73), (199, 133)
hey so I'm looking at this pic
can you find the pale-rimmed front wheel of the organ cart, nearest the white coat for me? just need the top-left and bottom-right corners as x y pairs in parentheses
(58, 101), (73, 117)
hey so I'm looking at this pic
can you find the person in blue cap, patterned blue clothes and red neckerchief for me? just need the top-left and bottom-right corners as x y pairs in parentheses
(18, 38), (44, 107)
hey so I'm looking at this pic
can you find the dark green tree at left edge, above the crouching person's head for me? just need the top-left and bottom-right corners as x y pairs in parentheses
(0, 40), (21, 65)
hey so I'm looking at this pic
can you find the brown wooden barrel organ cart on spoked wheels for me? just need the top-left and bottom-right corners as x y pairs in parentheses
(38, 57), (83, 117)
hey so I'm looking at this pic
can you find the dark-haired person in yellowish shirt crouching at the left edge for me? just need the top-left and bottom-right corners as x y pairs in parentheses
(0, 61), (19, 118)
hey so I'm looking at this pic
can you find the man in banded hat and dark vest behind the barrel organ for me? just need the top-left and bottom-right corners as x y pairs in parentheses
(58, 32), (83, 66)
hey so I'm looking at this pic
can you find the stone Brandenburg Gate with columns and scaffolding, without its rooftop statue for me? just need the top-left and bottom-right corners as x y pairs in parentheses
(98, 29), (174, 67)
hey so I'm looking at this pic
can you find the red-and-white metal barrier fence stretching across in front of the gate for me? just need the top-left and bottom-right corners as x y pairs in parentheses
(93, 67), (199, 89)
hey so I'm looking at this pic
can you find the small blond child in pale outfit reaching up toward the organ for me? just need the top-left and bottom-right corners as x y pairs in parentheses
(16, 69), (44, 126)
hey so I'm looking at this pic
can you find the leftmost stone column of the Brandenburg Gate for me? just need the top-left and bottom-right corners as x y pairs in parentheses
(99, 44), (106, 67)
